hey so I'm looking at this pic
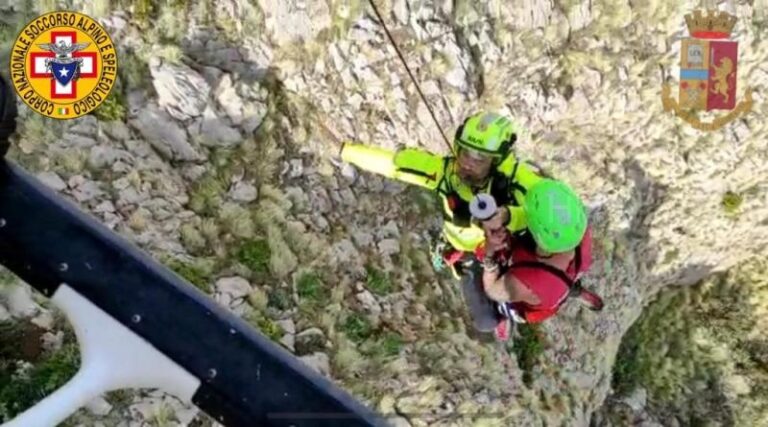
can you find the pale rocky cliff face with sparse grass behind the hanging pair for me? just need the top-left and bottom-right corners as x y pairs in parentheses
(0, 0), (768, 426)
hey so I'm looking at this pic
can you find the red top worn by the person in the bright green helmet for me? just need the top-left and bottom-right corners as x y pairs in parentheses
(475, 227), (592, 323)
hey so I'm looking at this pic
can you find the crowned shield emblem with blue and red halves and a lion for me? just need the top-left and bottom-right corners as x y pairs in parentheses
(662, 9), (752, 131)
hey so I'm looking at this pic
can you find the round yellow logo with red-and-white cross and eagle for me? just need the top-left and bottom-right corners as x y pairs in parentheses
(10, 11), (117, 119)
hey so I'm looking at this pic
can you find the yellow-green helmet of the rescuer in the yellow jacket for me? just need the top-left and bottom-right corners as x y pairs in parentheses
(455, 113), (517, 157)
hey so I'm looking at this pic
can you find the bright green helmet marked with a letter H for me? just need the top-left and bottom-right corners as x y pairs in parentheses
(524, 179), (587, 253)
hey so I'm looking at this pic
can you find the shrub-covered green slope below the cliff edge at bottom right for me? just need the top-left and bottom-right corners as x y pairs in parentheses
(612, 259), (768, 425)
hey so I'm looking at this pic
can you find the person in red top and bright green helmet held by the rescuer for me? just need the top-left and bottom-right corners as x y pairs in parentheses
(475, 179), (603, 340)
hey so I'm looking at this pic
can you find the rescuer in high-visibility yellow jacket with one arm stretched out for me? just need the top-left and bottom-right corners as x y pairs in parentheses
(341, 112), (542, 272)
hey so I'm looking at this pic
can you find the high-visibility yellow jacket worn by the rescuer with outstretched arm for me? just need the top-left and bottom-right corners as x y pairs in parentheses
(341, 143), (542, 252)
